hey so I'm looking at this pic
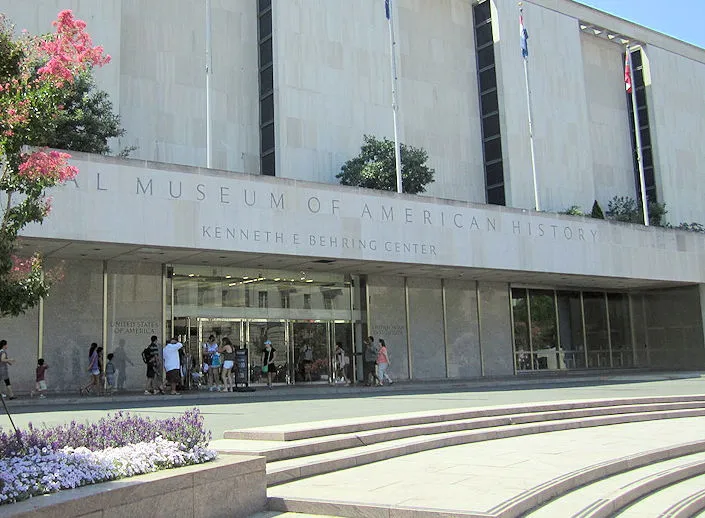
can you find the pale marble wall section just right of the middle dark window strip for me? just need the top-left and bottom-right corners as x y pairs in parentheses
(494, 0), (595, 211)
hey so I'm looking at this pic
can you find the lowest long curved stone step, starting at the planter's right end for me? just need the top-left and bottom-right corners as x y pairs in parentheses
(267, 408), (705, 486)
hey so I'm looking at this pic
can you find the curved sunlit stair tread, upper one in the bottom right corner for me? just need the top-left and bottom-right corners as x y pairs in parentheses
(526, 452), (705, 518)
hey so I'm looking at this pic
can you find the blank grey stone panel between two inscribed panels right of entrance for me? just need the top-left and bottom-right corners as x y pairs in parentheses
(407, 277), (446, 379)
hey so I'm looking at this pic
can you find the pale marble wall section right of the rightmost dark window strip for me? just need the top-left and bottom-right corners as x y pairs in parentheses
(646, 45), (705, 225)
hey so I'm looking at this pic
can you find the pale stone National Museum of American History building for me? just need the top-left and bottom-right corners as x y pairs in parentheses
(0, 0), (705, 392)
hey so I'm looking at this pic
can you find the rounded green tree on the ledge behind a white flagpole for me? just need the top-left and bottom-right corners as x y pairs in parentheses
(336, 135), (435, 194)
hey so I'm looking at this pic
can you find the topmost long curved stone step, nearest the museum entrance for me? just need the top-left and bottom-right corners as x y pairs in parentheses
(223, 394), (705, 441)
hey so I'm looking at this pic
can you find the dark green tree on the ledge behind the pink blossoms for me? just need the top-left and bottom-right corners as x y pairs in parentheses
(42, 73), (134, 156)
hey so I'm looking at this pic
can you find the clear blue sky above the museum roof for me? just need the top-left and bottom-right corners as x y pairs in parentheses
(577, 0), (705, 48)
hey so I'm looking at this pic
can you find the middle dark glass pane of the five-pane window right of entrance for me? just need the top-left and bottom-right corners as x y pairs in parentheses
(556, 291), (585, 369)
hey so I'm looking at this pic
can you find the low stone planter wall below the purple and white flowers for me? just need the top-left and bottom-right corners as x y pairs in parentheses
(0, 455), (267, 518)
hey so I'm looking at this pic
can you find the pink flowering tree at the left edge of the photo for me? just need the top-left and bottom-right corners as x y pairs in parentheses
(0, 11), (110, 316)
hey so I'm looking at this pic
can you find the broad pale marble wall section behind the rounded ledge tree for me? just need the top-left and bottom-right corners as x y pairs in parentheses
(273, 0), (485, 201)
